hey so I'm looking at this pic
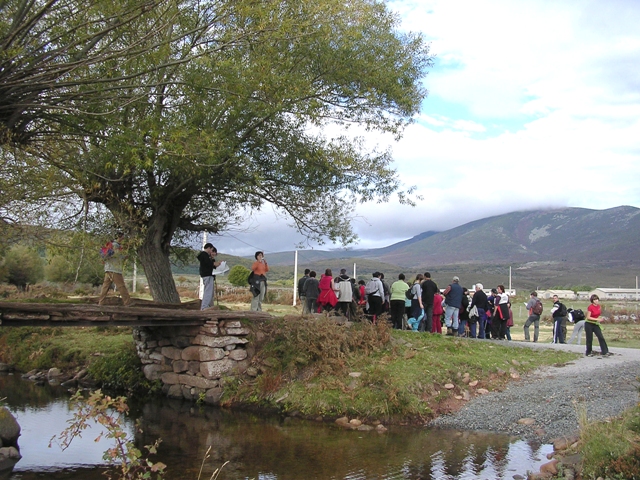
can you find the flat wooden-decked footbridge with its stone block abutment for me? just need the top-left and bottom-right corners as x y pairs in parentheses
(0, 300), (272, 404)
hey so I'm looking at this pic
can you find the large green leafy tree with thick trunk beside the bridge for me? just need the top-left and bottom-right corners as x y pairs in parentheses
(0, 0), (431, 302)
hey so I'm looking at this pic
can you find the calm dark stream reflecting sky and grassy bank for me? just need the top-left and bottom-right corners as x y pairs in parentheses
(0, 376), (552, 480)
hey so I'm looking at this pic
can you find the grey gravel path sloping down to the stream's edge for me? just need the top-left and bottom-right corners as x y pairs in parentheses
(429, 342), (640, 443)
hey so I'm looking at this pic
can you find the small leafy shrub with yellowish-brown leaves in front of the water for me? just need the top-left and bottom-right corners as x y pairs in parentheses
(49, 390), (166, 480)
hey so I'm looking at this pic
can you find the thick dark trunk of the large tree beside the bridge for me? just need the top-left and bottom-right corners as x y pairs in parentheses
(138, 219), (180, 303)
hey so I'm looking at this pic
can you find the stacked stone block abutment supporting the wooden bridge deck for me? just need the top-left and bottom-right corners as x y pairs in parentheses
(133, 319), (255, 405)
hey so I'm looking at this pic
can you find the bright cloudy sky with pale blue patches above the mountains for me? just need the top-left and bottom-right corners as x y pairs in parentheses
(208, 0), (640, 255)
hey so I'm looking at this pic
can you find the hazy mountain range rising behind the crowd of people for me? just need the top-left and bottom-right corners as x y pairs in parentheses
(262, 206), (640, 288)
